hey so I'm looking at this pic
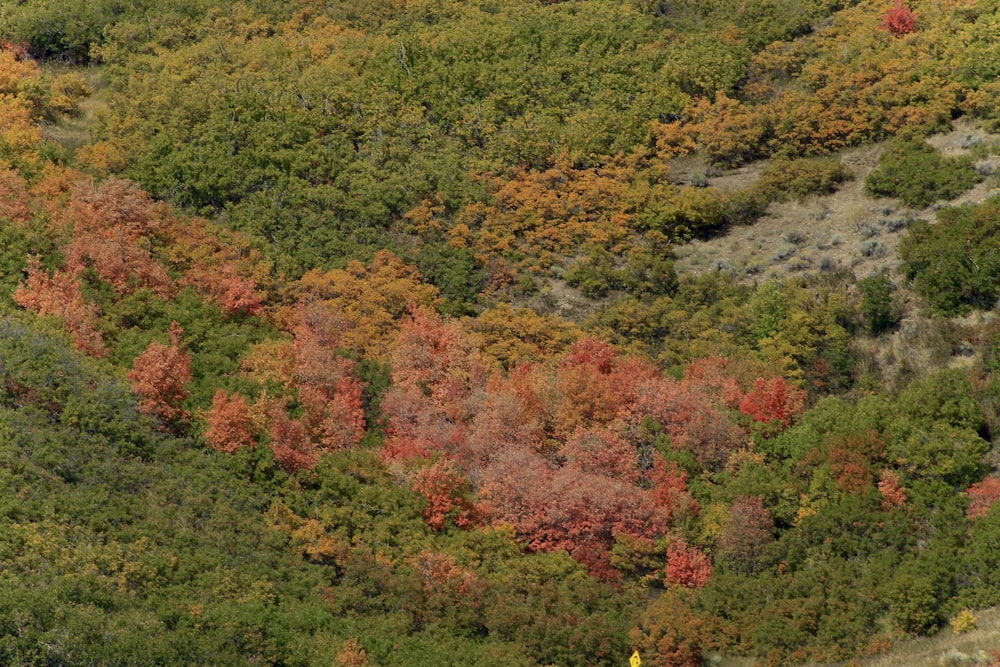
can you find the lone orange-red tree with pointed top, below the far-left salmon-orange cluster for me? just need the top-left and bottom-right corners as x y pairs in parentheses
(128, 322), (191, 422)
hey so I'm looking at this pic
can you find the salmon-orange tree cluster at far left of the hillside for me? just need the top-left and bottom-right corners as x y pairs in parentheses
(15, 175), (263, 356)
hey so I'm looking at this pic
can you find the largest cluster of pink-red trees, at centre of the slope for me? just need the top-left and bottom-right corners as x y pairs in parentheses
(382, 310), (804, 586)
